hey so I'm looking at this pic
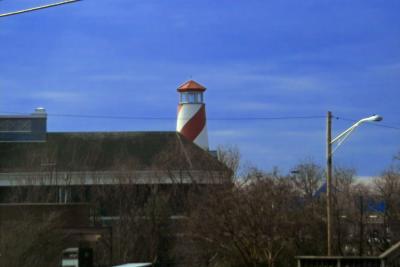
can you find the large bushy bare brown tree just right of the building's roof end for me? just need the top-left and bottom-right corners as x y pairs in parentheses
(187, 170), (298, 267)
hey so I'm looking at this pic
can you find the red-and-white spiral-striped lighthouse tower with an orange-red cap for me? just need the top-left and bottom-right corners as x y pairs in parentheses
(176, 80), (208, 150)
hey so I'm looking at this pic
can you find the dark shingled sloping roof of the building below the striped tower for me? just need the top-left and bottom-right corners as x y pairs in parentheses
(0, 132), (226, 172)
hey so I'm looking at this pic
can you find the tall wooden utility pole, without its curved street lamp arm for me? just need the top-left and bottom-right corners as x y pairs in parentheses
(326, 111), (332, 256)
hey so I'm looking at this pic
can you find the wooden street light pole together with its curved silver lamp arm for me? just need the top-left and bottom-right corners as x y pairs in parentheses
(326, 111), (383, 256)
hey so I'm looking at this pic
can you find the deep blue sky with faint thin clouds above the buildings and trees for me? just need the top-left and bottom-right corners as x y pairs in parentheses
(0, 0), (400, 176)
